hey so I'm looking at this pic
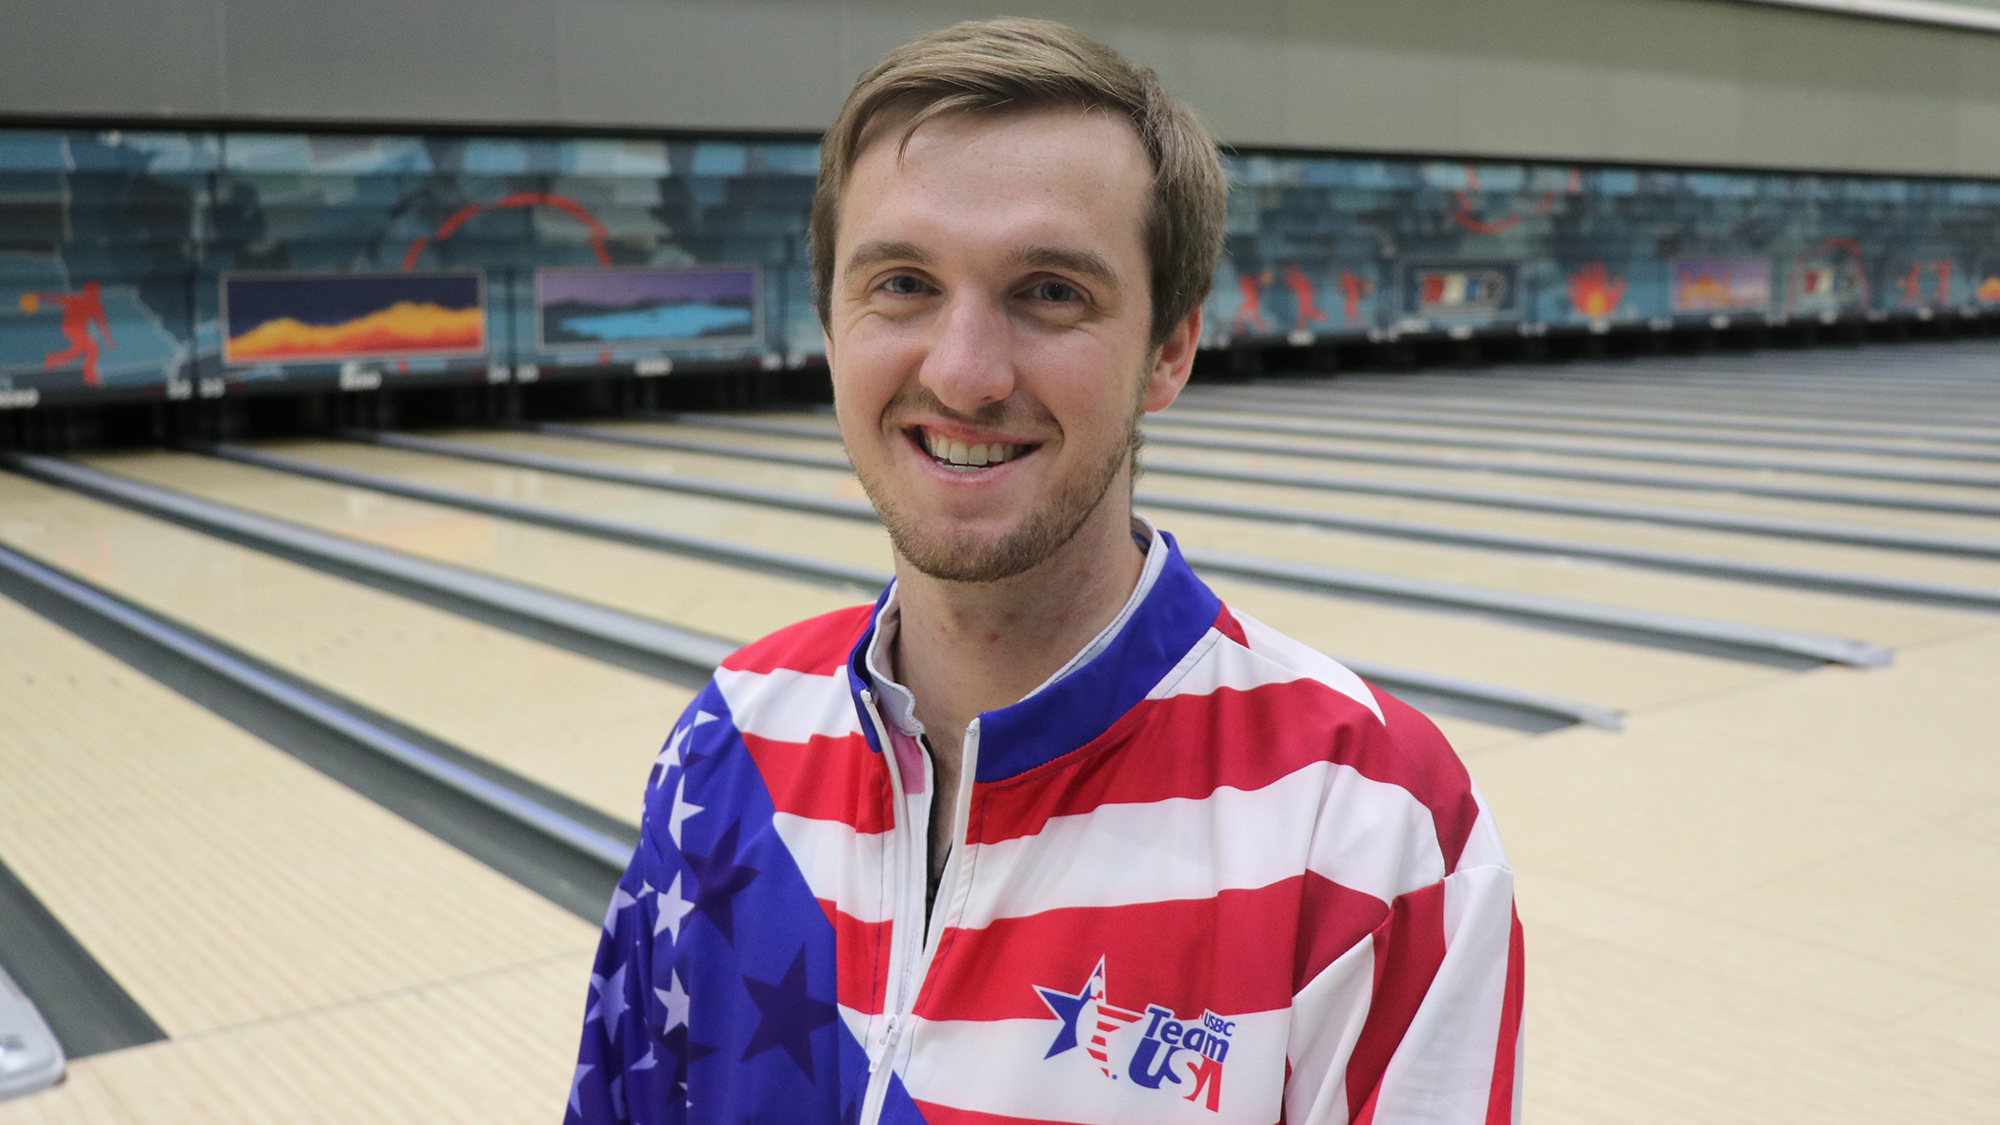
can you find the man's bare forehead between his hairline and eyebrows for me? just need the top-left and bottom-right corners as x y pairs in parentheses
(838, 110), (1152, 252)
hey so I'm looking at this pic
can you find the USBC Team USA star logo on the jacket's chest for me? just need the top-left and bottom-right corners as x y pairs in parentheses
(1034, 957), (1236, 1113)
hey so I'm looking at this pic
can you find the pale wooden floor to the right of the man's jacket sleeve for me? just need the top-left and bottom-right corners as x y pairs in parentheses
(1468, 629), (2000, 1125)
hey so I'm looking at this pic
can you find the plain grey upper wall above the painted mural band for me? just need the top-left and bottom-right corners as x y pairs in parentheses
(0, 0), (2000, 176)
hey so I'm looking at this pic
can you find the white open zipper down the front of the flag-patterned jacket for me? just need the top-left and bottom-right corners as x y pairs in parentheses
(860, 689), (980, 1125)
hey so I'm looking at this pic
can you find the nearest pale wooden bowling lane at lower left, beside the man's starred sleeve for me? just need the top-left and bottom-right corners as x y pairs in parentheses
(0, 592), (594, 1040)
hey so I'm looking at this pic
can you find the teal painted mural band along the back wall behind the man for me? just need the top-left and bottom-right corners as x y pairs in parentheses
(0, 130), (2000, 408)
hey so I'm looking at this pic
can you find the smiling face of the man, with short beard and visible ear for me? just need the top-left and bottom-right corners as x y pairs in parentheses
(826, 110), (1198, 583)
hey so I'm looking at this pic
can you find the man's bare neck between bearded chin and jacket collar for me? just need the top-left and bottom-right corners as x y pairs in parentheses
(894, 484), (1146, 759)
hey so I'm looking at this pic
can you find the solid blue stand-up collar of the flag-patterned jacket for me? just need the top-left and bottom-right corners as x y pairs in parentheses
(848, 532), (1222, 783)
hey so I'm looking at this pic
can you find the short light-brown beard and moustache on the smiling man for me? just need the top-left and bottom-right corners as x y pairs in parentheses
(856, 388), (1144, 583)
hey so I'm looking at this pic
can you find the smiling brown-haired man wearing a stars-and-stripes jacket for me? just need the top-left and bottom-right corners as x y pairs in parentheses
(570, 20), (1520, 1125)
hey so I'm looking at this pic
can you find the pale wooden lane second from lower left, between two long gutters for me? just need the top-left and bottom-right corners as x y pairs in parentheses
(0, 468), (692, 823)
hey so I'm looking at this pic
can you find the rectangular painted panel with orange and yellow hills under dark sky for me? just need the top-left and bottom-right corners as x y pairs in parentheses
(222, 270), (486, 366)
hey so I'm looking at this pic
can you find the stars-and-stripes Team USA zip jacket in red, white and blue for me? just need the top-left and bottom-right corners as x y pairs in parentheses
(566, 534), (1522, 1125)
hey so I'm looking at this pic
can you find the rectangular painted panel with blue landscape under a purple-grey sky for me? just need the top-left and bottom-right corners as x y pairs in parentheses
(534, 266), (762, 350)
